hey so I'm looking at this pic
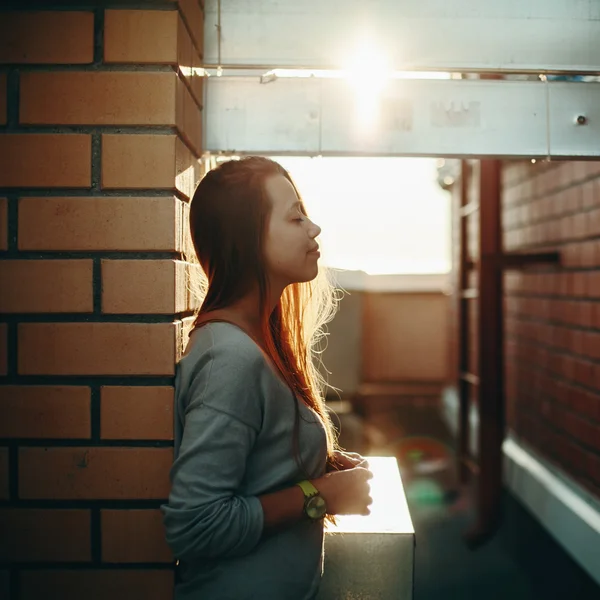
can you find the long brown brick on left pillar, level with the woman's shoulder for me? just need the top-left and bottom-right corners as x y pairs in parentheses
(18, 323), (176, 375)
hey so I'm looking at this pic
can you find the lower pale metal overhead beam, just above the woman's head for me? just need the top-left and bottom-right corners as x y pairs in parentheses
(204, 77), (600, 158)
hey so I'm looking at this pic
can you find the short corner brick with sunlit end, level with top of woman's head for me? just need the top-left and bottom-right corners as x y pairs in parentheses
(102, 134), (199, 198)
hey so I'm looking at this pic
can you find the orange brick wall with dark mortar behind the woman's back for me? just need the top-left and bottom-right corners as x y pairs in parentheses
(0, 0), (203, 600)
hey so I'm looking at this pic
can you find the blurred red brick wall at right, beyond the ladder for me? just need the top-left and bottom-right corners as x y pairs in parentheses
(503, 162), (600, 497)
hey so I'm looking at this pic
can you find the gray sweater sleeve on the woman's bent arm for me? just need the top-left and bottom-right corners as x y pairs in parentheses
(162, 346), (264, 559)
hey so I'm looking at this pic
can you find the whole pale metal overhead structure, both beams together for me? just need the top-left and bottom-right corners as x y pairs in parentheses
(204, 0), (600, 158)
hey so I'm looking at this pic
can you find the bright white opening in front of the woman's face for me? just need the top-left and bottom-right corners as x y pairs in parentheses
(273, 156), (450, 275)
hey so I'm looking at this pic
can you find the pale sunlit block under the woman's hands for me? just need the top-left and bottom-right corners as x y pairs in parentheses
(317, 457), (415, 600)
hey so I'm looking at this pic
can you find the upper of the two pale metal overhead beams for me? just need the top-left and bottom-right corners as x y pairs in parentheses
(204, 0), (600, 74)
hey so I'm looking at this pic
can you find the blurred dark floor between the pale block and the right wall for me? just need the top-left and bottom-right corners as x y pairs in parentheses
(332, 402), (600, 600)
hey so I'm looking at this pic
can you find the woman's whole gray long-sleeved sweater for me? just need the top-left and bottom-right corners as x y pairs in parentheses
(161, 323), (327, 600)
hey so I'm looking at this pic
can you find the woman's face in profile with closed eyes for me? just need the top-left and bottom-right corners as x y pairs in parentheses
(264, 175), (321, 287)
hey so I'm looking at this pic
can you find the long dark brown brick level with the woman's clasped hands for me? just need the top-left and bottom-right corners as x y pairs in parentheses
(19, 447), (173, 500)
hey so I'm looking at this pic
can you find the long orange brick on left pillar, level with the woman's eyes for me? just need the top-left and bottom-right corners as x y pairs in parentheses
(18, 197), (181, 252)
